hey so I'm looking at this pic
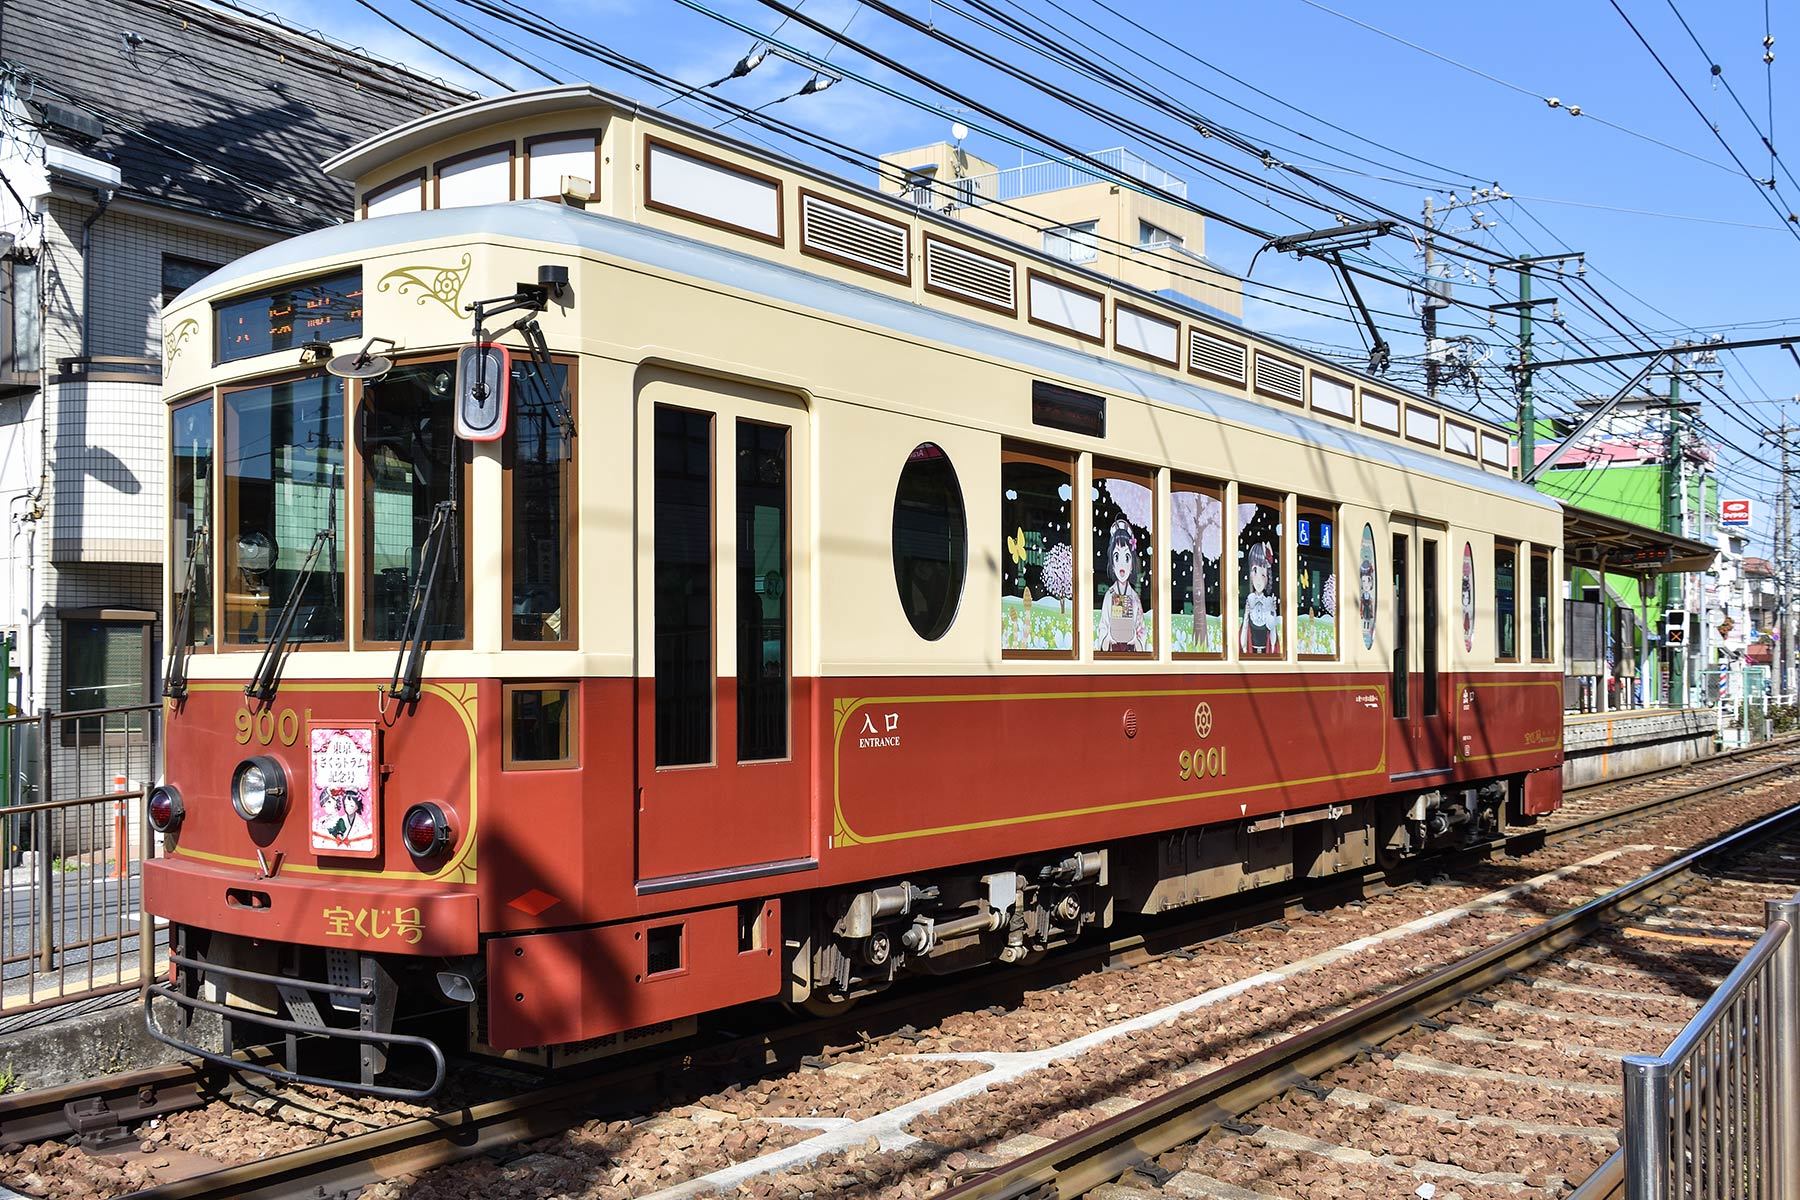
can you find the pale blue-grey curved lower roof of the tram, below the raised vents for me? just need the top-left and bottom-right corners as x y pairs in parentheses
(175, 203), (1557, 509)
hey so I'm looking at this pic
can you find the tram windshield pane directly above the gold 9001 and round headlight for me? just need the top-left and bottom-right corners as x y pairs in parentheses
(220, 374), (346, 646)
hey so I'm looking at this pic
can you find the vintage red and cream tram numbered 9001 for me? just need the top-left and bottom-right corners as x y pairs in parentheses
(146, 86), (1561, 1092)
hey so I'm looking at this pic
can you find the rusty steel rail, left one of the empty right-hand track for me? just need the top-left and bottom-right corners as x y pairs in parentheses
(941, 791), (1800, 1200)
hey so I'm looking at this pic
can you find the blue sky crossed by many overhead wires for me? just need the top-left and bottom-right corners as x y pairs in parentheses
(275, 0), (1800, 545)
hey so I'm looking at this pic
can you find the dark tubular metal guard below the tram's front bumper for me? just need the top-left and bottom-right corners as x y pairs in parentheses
(144, 954), (446, 1099)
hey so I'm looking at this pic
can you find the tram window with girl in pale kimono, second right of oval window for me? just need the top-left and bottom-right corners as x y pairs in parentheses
(1089, 462), (1156, 655)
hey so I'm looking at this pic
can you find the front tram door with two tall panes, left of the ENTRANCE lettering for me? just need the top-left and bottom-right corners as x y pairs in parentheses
(635, 371), (812, 889)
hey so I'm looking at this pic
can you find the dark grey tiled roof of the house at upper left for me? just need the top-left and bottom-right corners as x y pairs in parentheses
(0, 0), (472, 232)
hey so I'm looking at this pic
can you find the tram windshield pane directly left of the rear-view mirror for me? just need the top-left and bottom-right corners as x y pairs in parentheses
(356, 360), (468, 642)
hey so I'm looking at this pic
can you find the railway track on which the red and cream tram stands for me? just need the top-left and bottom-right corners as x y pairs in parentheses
(0, 739), (1800, 1200)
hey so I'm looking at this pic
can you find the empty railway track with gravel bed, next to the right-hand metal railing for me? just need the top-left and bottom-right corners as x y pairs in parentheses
(945, 791), (1800, 1200)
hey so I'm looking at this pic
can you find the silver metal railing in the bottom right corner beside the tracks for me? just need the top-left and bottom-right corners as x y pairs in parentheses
(1625, 896), (1800, 1200)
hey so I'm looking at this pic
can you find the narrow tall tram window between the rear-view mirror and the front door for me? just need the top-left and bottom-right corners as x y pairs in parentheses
(506, 363), (574, 646)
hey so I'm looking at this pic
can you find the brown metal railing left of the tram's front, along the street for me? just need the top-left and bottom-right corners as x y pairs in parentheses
(0, 703), (166, 1018)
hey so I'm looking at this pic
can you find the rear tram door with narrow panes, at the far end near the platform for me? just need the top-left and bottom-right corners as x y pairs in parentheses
(1388, 516), (1453, 783)
